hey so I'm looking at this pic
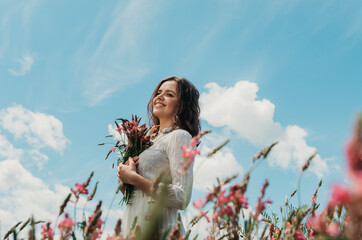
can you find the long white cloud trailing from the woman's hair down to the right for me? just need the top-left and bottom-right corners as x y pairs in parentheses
(200, 81), (328, 177)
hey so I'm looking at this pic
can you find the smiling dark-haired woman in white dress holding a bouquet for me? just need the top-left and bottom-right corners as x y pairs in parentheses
(117, 76), (200, 236)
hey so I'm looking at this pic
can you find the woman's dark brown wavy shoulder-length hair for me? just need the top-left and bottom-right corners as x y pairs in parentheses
(147, 76), (201, 137)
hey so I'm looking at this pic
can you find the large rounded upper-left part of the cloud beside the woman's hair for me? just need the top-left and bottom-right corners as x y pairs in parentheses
(200, 81), (283, 145)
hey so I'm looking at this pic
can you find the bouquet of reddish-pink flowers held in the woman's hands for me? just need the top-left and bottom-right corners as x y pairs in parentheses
(102, 115), (158, 204)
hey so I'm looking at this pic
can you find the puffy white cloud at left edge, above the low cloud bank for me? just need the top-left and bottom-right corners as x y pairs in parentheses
(0, 105), (69, 153)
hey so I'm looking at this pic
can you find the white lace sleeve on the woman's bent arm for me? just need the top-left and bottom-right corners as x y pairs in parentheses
(161, 129), (193, 210)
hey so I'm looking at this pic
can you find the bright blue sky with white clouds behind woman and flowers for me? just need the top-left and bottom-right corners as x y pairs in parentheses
(0, 0), (362, 236)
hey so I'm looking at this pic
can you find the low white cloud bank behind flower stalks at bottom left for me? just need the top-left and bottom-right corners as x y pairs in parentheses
(0, 159), (123, 237)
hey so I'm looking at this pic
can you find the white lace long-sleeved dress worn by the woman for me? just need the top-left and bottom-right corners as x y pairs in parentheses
(122, 128), (193, 236)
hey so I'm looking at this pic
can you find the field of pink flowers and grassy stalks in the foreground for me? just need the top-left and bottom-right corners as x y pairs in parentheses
(4, 116), (362, 240)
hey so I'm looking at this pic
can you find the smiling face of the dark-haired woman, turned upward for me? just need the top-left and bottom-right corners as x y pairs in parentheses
(153, 80), (179, 121)
